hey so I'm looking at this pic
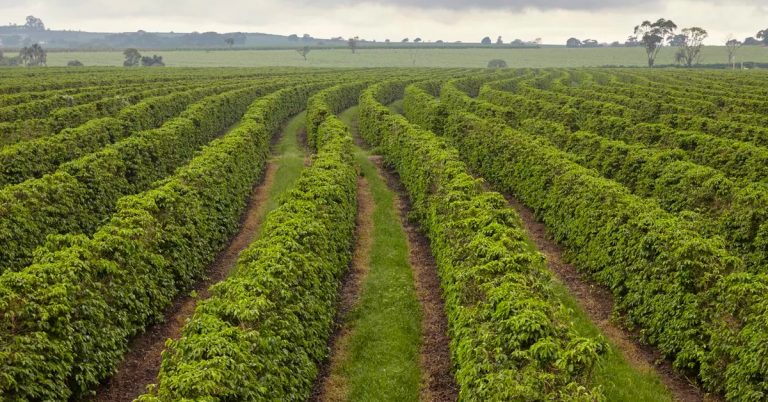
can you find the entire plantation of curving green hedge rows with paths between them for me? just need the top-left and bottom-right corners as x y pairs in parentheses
(0, 66), (768, 402)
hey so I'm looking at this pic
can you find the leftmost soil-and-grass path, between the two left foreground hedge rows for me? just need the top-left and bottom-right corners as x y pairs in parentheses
(91, 113), (304, 402)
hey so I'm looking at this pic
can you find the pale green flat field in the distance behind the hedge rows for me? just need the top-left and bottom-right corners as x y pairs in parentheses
(48, 46), (768, 67)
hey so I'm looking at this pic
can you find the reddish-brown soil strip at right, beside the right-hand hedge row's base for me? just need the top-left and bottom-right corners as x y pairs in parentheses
(505, 195), (717, 402)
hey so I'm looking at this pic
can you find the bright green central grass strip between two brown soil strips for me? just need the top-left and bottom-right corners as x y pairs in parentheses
(332, 108), (421, 401)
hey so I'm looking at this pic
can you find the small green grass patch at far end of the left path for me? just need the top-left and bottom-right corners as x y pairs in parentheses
(264, 112), (306, 215)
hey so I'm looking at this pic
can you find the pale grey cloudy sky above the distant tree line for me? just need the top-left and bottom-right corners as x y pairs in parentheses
(0, 0), (768, 44)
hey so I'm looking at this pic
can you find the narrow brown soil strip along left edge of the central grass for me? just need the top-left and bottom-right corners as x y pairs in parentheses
(310, 177), (375, 402)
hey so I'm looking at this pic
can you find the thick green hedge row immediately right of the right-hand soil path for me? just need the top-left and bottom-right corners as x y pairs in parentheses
(438, 105), (768, 400)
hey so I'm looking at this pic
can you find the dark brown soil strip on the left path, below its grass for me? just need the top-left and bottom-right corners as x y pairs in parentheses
(92, 132), (278, 402)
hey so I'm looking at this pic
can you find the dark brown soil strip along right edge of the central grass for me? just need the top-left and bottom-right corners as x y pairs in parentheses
(370, 157), (458, 402)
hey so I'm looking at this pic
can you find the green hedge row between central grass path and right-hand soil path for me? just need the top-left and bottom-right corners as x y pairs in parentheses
(360, 84), (605, 401)
